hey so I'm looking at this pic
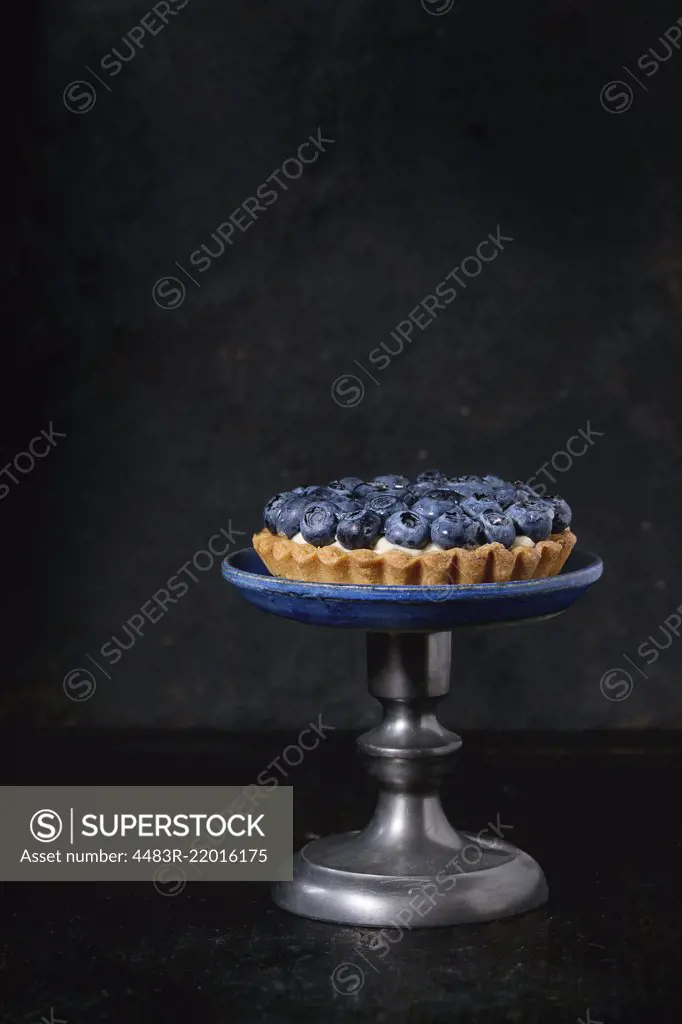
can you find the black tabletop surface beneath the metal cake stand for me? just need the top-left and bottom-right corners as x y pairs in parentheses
(0, 731), (682, 1024)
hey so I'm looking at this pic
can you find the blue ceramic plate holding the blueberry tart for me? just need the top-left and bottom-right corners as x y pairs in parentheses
(222, 548), (603, 631)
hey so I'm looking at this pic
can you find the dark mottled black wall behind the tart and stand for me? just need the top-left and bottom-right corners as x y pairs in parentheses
(5, 0), (682, 729)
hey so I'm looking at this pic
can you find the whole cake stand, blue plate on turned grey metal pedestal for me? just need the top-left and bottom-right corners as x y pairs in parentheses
(222, 548), (602, 928)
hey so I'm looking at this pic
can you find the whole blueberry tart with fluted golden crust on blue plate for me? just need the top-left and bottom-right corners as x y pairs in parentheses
(253, 470), (576, 586)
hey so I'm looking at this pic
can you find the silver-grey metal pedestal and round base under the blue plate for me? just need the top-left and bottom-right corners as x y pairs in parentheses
(274, 633), (547, 928)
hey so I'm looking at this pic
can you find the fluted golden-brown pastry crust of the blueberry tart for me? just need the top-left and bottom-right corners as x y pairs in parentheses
(253, 529), (577, 587)
